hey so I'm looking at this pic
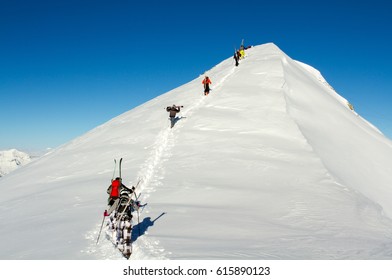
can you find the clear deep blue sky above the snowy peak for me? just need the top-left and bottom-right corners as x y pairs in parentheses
(0, 0), (392, 150)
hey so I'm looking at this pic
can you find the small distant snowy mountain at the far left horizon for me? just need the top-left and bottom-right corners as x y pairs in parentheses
(0, 149), (31, 177)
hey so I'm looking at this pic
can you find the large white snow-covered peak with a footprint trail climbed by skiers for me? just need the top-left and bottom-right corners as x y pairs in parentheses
(0, 43), (392, 259)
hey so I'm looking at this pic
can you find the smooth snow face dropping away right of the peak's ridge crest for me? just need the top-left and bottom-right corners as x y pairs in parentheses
(283, 49), (392, 218)
